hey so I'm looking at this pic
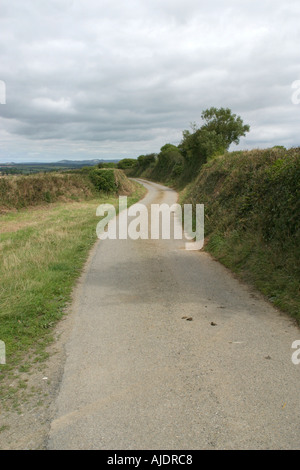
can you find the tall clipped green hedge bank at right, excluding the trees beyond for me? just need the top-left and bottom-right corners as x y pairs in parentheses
(181, 149), (300, 322)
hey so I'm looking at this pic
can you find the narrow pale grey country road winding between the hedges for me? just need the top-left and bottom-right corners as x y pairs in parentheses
(48, 182), (300, 450)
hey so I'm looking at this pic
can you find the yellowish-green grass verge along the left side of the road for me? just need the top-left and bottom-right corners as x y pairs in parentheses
(0, 182), (145, 399)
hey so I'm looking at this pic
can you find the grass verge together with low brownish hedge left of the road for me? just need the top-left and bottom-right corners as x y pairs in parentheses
(0, 168), (145, 406)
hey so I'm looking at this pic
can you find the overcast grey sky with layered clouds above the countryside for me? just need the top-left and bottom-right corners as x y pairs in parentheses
(0, 0), (300, 162)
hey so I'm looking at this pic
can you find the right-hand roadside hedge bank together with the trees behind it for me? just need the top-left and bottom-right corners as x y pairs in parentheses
(123, 108), (300, 323)
